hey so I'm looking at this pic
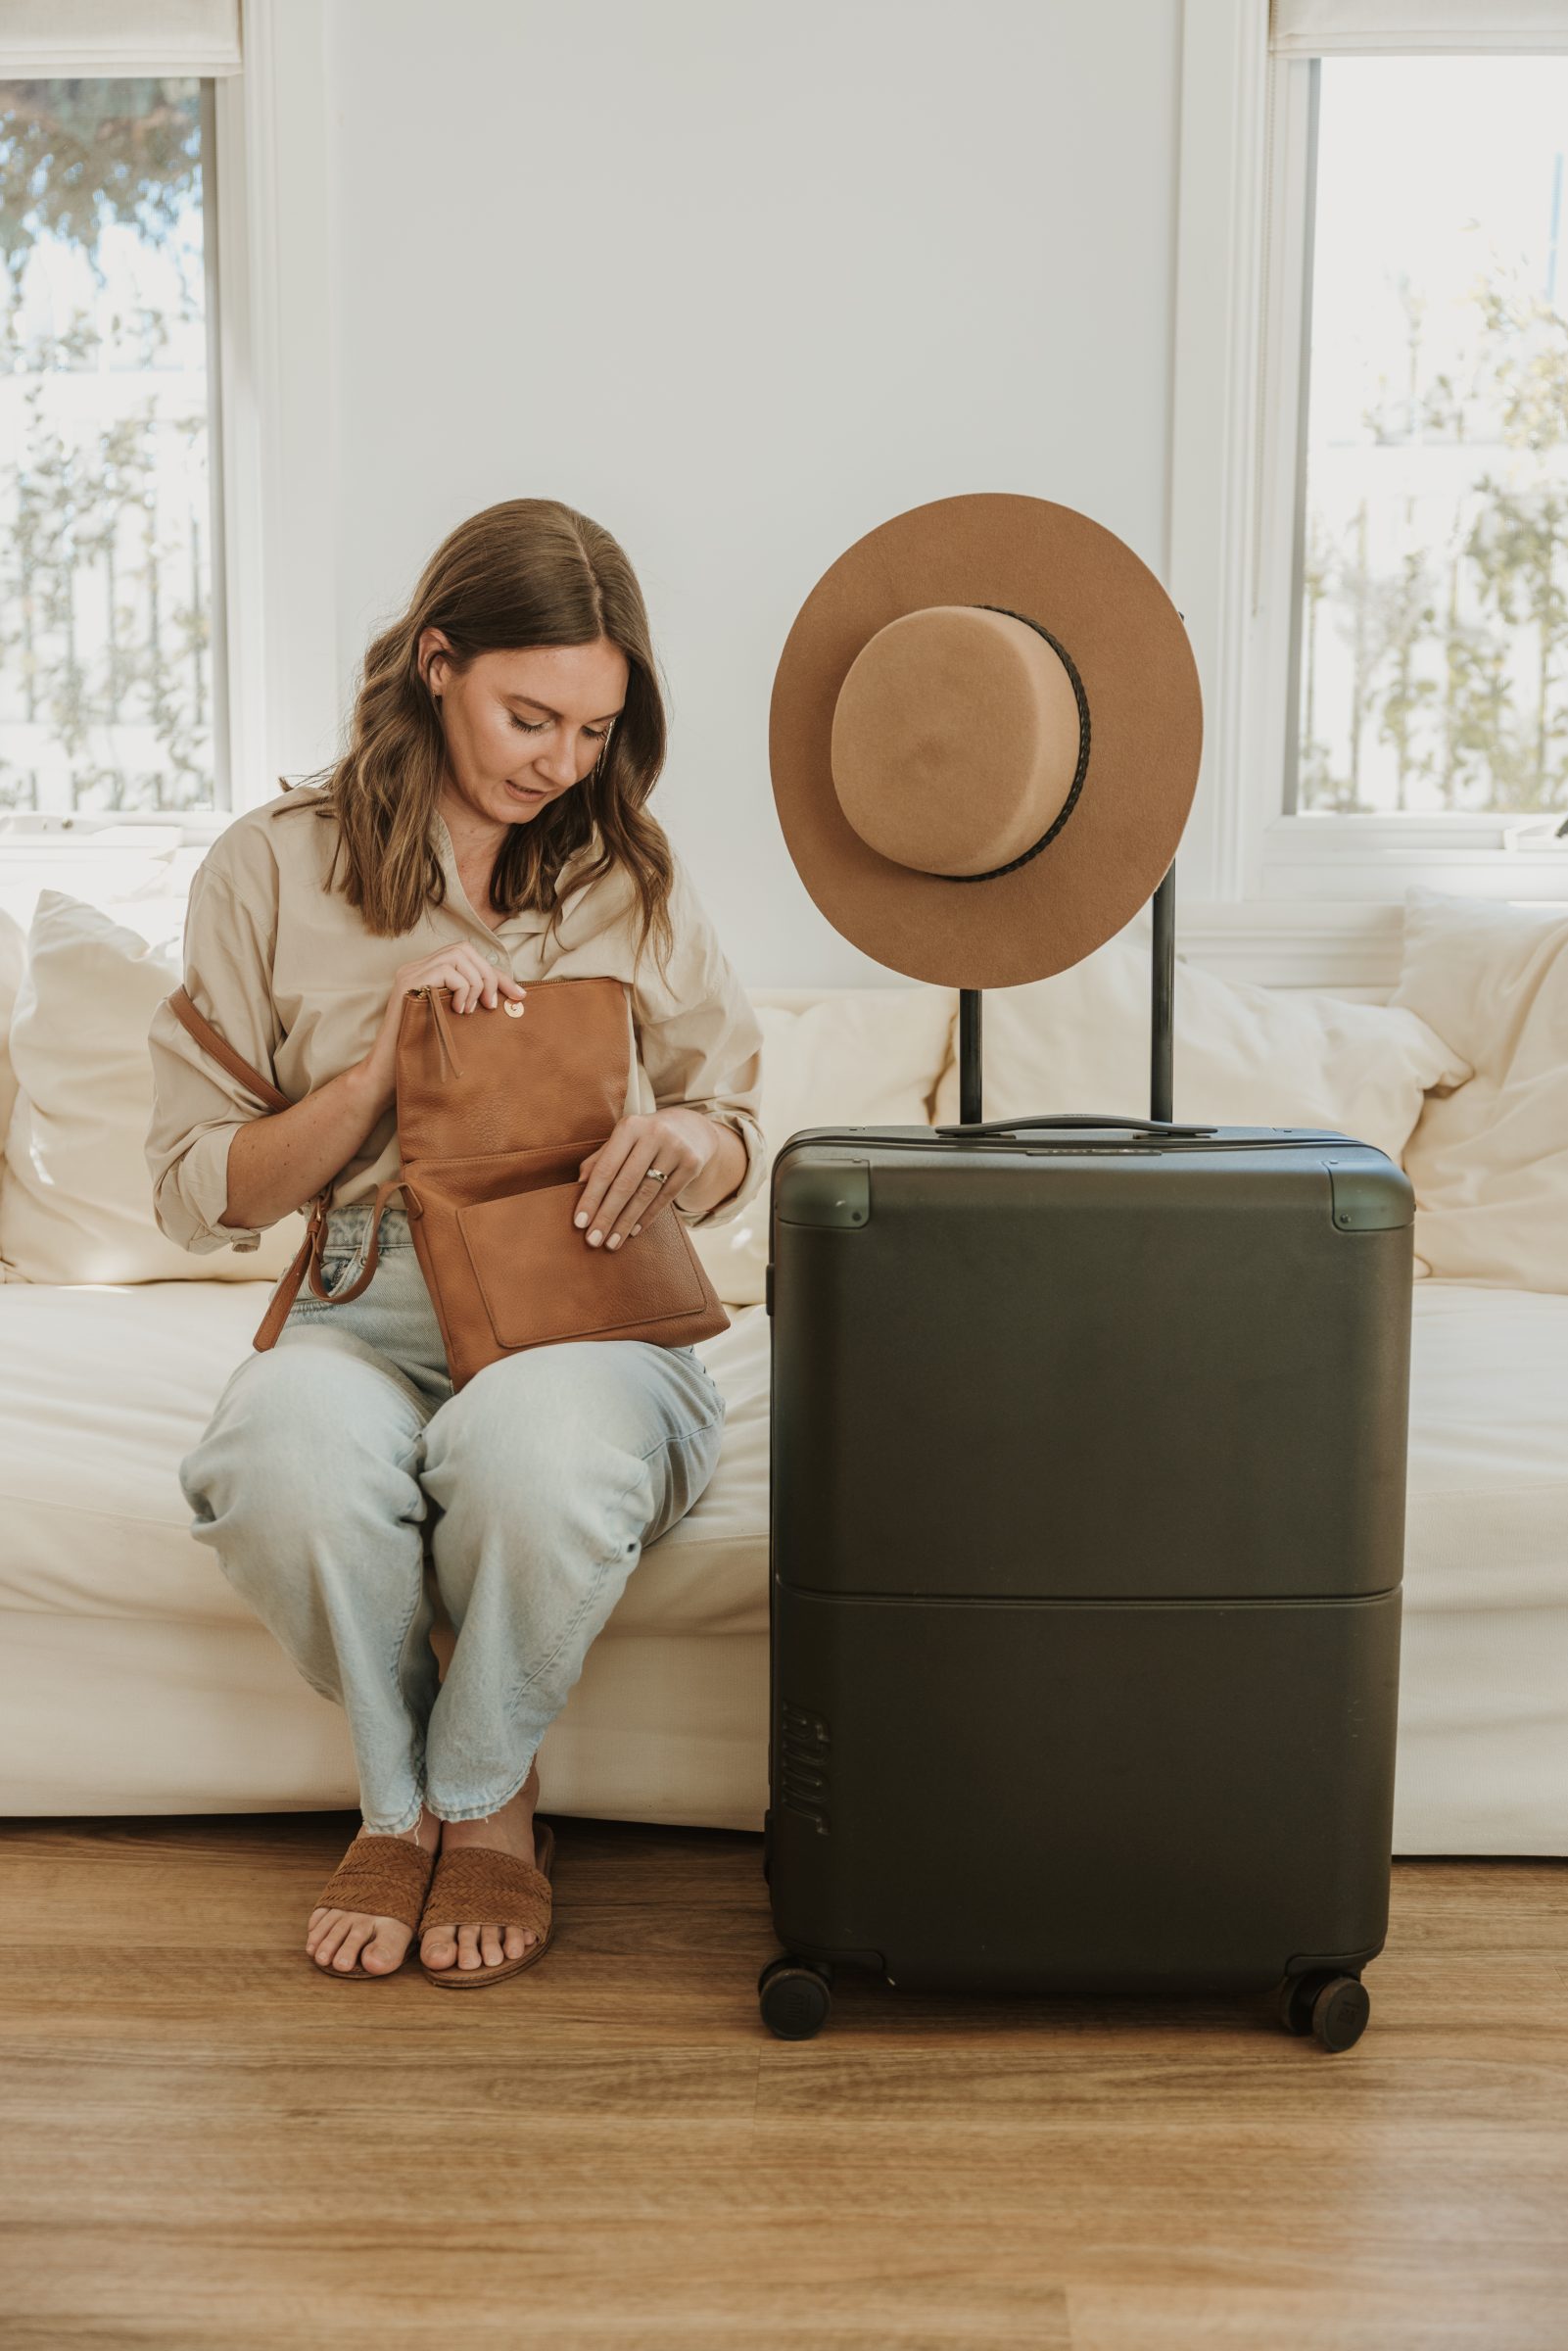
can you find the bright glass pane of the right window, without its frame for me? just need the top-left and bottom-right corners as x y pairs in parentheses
(1286, 57), (1568, 825)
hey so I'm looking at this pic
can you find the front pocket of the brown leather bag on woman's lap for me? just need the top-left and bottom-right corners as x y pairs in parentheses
(456, 1177), (707, 1347)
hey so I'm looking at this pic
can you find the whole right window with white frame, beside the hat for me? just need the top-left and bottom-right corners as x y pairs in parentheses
(1166, 0), (1568, 907)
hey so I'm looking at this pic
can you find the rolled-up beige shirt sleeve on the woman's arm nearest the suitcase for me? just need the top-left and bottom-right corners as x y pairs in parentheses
(633, 856), (766, 1229)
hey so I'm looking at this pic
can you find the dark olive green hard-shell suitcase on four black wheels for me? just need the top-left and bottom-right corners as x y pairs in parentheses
(759, 870), (1413, 2047)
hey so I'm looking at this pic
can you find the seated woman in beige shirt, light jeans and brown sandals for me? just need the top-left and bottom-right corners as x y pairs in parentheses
(148, 499), (764, 1987)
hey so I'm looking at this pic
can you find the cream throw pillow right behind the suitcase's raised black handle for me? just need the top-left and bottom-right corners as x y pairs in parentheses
(933, 912), (1469, 1159)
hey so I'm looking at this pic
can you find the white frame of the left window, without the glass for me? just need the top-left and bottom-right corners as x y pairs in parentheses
(0, 0), (343, 841)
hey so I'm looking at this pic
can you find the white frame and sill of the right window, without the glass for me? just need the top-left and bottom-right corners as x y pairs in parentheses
(1168, 0), (1568, 926)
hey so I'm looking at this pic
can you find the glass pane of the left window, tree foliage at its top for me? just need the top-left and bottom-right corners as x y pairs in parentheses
(0, 77), (228, 813)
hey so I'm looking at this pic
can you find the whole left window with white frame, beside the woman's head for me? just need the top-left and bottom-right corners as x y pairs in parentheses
(0, 0), (333, 855)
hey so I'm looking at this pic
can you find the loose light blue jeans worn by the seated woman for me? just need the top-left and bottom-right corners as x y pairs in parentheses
(178, 1204), (724, 1834)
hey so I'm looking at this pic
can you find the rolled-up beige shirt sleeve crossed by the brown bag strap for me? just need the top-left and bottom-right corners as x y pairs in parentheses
(146, 851), (282, 1256)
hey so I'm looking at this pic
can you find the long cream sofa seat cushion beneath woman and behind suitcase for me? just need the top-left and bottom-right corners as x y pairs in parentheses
(0, 1281), (1568, 1646)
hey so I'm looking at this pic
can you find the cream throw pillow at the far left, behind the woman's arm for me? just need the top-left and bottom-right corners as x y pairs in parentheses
(0, 888), (306, 1281)
